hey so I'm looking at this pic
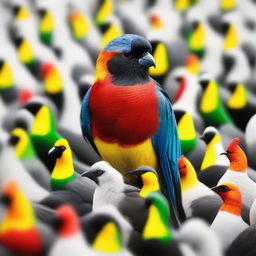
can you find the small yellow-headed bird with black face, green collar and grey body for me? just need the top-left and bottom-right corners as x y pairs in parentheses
(40, 138), (96, 215)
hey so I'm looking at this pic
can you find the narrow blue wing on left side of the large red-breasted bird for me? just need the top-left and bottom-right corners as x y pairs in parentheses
(80, 88), (98, 152)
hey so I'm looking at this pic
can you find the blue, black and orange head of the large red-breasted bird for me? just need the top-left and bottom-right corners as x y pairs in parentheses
(96, 34), (155, 86)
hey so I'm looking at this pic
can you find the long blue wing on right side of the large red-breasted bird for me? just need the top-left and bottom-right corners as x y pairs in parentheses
(152, 82), (181, 208)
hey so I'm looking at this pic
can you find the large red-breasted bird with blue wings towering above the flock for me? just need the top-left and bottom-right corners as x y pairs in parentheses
(81, 34), (183, 222)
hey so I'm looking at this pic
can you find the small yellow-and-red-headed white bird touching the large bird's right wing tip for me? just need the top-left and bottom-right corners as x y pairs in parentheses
(179, 156), (222, 224)
